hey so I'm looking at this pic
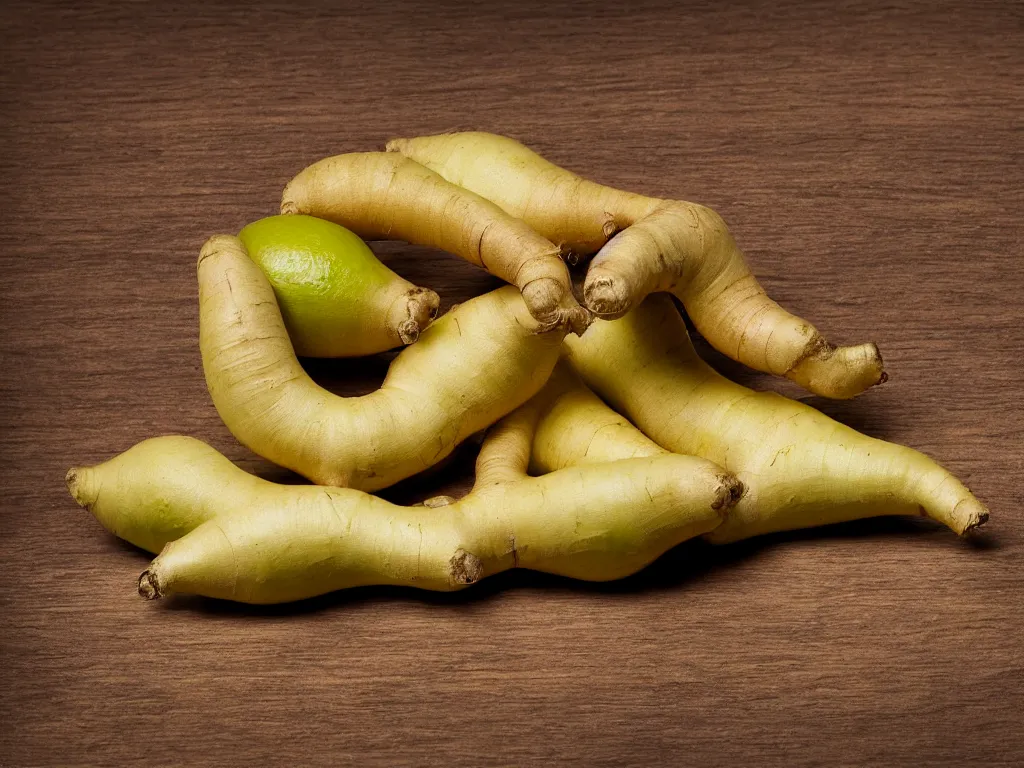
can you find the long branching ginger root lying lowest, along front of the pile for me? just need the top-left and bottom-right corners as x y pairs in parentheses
(69, 430), (740, 603)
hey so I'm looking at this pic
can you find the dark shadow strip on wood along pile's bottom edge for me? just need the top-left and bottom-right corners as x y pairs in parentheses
(148, 517), (999, 616)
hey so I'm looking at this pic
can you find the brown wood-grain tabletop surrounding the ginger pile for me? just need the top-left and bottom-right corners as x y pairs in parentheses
(0, 2), (1024, 766)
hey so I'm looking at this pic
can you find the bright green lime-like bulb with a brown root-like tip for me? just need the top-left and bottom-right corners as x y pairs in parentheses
(239, 216), (439, 357)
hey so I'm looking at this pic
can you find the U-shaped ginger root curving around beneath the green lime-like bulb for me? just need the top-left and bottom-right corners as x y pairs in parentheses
(198, 236), (565, 490)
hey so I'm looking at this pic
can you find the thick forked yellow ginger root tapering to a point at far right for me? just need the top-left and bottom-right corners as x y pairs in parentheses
(552, 296), (988, 543)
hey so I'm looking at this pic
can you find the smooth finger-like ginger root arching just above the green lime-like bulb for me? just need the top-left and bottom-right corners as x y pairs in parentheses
(281, 153), (591, 333)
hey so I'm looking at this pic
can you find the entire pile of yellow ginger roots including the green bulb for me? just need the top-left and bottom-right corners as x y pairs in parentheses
(67, 133), (988, 603)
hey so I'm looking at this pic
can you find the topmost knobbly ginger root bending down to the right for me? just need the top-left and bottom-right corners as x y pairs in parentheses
(387, 132), (885, 398)
